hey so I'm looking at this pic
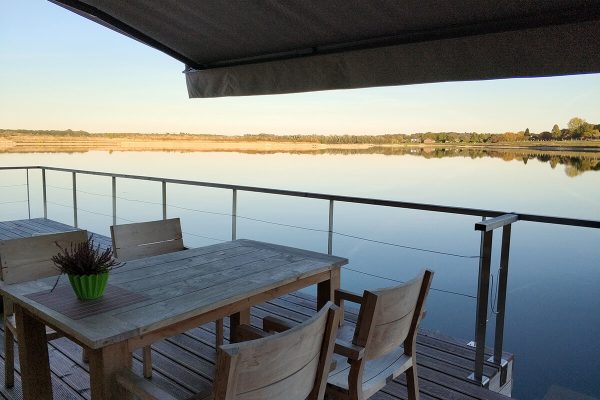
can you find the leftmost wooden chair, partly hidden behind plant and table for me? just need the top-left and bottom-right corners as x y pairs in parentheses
(0, 231), (88, 388)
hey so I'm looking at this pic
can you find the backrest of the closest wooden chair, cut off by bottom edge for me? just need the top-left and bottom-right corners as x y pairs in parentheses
(213, 302), (339, 400)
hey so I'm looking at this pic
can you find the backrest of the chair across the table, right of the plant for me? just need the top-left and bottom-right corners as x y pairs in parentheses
(110, 218), (185, 261)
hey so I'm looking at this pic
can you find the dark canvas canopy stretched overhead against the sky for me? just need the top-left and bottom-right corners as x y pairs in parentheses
(51, 0), (600, 97)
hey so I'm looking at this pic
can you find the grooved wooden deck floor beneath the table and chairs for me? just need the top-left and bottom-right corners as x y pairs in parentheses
(0, 218), (513, 400)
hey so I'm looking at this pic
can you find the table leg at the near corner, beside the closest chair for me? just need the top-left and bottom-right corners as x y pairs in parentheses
(88, 342), (131, 400)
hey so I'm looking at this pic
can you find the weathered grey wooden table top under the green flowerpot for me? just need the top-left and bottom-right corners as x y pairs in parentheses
(0, 239), (348, 348)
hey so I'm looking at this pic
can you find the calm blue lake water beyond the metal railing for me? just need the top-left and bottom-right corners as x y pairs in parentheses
(0, 150), (600, 399)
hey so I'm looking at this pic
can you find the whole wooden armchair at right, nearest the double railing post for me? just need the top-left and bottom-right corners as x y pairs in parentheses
(263, 270), (433, 400)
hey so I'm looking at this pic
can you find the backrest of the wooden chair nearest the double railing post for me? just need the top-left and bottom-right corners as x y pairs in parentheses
(353, 270), (433, 360)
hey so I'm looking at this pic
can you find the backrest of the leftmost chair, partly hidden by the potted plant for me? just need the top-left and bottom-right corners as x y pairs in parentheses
(0, 231), (88, 284)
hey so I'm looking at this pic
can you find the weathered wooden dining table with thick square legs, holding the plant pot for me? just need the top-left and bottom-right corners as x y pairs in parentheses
(0, 240), (348, 400)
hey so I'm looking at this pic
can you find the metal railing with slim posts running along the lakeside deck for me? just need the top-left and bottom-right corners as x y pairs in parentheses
(0, 166), (600, 386)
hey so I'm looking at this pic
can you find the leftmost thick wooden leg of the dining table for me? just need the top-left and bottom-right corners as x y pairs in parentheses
(15, 304), (52, 400)
